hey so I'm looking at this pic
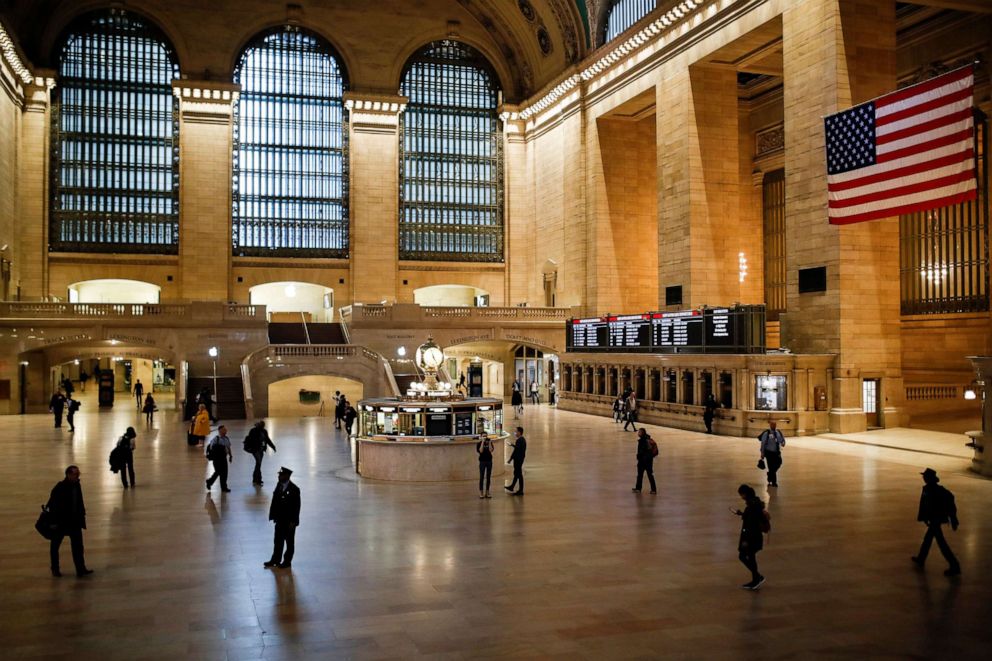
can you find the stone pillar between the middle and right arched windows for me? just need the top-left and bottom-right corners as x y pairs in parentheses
(344, 92), (407, 303)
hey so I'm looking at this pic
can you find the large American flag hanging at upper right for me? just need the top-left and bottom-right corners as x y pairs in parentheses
(823, 65), (977, 225)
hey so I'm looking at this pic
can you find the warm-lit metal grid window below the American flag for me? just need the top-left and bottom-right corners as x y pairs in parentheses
(899, 118), (989, 314)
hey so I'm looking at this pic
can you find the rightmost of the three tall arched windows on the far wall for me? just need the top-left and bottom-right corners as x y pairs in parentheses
(399, 40), (503, 262)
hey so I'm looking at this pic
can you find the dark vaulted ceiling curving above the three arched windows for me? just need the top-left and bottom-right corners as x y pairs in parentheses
(0, 0), (596, 100)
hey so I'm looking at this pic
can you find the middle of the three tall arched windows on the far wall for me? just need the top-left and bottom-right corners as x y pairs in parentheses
(232, 26), (348, 257)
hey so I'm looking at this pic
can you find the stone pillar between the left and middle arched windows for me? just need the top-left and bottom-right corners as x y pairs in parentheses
(172, 80), (241, 302)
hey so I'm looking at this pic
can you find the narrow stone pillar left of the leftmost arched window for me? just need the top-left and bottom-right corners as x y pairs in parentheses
(18, 77), (51, 300)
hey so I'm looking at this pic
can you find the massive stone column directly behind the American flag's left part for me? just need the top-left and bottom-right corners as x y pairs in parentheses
(782, 0), (904, 432)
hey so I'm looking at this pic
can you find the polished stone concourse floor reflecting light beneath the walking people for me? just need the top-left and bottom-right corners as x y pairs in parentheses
(0, 400), (992, 661)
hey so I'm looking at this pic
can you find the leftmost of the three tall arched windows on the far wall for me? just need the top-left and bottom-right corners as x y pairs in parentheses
(48, 9), (179, 254)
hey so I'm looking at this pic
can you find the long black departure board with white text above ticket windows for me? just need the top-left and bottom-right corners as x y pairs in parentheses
(565, 305), (765, 353)
